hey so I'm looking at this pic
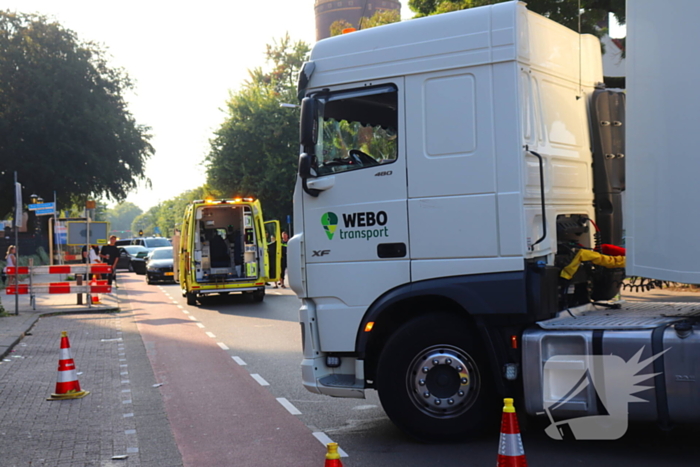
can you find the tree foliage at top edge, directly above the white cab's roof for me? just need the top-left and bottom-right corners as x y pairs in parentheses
(408, 0), (625, 35)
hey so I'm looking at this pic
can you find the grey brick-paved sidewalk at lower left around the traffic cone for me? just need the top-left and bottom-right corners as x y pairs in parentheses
(0, 276), (182, 467)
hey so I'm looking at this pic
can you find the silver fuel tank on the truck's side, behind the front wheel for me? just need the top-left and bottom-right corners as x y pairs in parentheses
(522, 303), (700, 425)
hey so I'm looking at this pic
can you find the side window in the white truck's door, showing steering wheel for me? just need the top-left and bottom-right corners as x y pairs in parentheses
(314, 86), (398, 175)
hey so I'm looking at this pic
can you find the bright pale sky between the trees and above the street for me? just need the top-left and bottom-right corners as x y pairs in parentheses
(0, 0), (412, 211)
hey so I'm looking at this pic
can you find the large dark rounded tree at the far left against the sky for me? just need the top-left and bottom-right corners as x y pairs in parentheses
(0, 12), (154, 216)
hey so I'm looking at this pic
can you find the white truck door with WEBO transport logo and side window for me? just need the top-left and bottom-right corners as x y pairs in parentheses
(300, 78), (409, 350)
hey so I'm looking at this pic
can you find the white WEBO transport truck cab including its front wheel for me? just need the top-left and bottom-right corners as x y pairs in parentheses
(288, 2), (700, 439)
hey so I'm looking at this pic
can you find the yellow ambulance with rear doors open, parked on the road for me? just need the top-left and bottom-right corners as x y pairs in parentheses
(173, 198), (282, 305)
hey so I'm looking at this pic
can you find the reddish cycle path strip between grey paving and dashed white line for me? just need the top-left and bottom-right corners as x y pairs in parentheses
(120, 278), (325, 467)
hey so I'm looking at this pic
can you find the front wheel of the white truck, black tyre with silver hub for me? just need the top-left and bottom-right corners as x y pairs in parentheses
(376, 313), (500, 441)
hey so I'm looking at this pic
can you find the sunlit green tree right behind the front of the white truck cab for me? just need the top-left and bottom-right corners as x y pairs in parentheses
(205, 35), (309, 219)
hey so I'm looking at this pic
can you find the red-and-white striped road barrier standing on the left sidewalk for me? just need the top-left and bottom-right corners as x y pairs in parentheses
(5, 263), (112, 309)
